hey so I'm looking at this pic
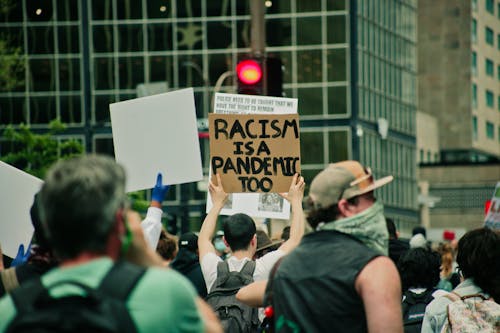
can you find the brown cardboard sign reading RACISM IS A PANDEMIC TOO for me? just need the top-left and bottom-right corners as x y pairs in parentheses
(209, 113), (300, 193)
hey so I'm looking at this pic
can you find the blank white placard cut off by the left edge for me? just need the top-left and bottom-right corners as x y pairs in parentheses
(0, 162), (43, 258)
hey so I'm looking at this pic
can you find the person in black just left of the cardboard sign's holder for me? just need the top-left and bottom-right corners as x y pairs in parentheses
(170, 232), (207, 298)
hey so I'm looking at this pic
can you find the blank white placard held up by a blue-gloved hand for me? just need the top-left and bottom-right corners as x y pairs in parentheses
(109, 88), (203, 192)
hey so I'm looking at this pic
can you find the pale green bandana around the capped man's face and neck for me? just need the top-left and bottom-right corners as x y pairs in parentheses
(318, 202), (389, 255)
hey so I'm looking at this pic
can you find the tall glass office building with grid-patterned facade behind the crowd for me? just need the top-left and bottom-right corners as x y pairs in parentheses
(0, 0), (418, 230)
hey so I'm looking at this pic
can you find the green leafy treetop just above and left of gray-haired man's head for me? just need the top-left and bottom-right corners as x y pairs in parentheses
(0, 119), (83, 179)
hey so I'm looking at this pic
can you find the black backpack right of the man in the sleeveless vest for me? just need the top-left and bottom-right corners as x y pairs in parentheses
(402, 289), (435, 333)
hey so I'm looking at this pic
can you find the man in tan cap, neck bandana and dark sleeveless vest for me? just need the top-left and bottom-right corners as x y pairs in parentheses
(266, 161), (403, 332)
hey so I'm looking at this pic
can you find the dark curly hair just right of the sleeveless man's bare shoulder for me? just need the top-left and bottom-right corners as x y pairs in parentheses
(397, 247), (441, 291)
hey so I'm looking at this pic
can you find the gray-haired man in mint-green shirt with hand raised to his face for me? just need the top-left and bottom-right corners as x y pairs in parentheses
(0, 155), (220, 332)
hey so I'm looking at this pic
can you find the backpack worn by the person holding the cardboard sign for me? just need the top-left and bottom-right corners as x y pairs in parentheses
(206, 260), (259, 333)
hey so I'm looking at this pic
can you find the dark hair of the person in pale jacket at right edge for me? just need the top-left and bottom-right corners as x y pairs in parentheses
(457, 228), (500, 303)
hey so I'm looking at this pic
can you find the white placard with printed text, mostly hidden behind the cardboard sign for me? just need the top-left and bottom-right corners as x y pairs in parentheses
(206, 93), (298, 220)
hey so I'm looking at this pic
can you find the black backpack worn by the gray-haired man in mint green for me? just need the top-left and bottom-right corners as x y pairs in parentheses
(6, 262), (145, 333)
